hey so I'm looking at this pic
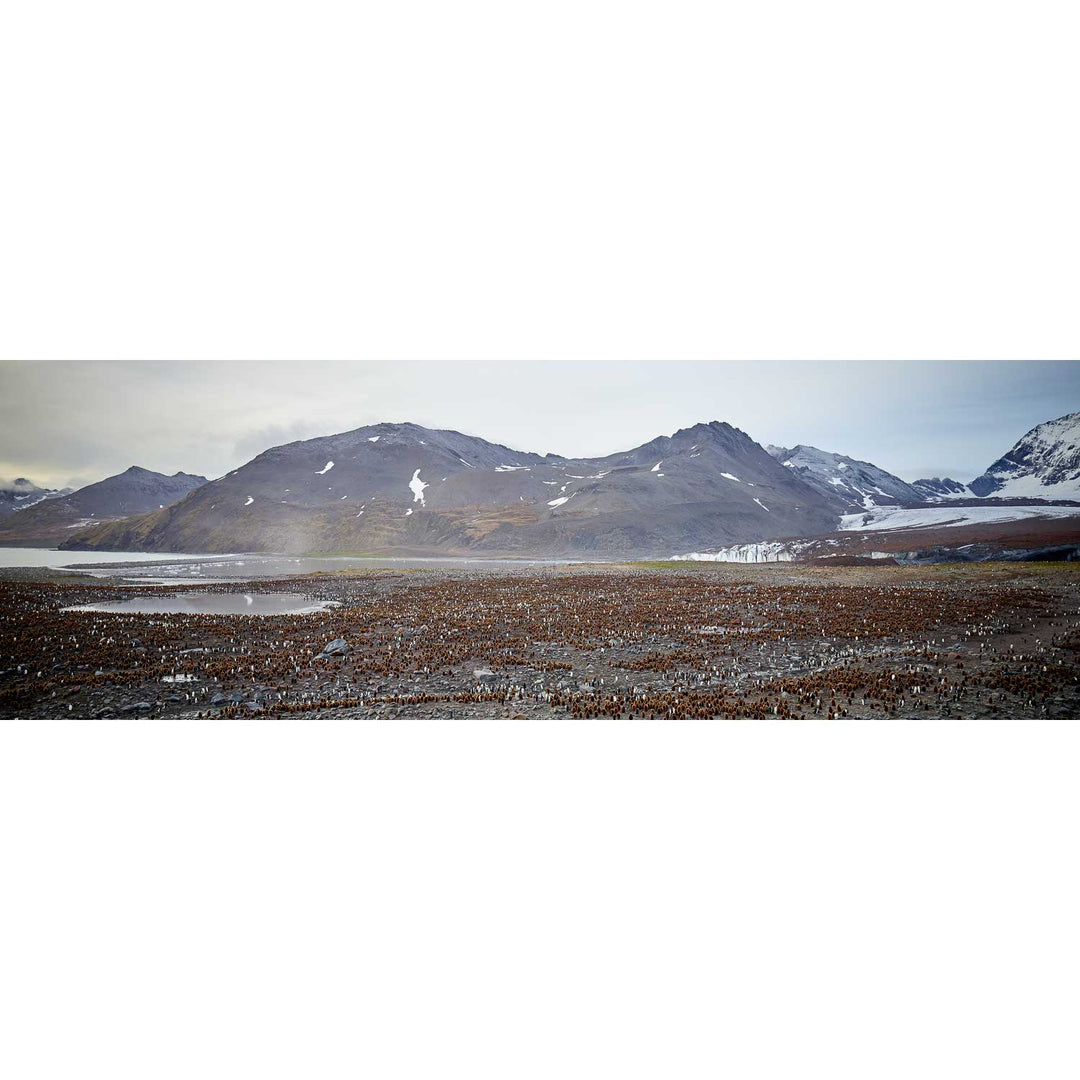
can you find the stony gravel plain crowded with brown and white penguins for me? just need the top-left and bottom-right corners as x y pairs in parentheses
(0, 564), (1080, 719)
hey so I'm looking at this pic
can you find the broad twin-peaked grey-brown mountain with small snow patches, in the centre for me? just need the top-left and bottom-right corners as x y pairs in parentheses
(64, 421), (849, 557)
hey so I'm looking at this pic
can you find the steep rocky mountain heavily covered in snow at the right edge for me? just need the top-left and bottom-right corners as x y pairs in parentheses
(968, 413), (1080, 499)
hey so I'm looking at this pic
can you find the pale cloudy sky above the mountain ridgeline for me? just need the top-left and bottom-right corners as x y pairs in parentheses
(0, 360), (1080, 486)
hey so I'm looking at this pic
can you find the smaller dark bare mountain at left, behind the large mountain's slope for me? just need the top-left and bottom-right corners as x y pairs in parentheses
(0, 465), (206, 546)
